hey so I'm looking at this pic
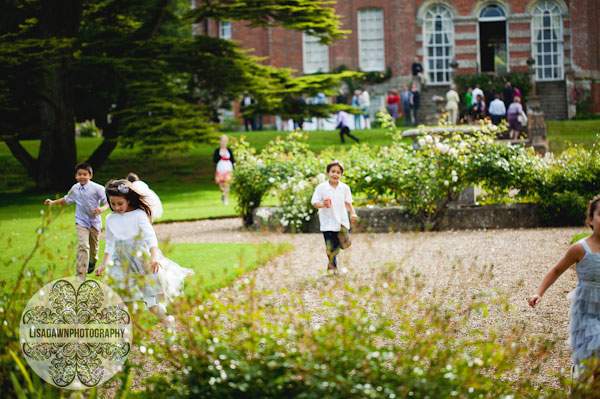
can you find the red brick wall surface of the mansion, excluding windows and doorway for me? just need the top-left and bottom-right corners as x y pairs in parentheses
(196, 0), (600, 111)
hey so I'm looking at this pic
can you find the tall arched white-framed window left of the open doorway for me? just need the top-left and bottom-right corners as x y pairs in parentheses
(423, 4), (454, 85)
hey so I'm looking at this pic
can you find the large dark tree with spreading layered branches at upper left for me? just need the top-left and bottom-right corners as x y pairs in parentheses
(0, 0), (352, 189)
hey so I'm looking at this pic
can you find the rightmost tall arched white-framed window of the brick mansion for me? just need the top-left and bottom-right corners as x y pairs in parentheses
(531, 0), (565, 81)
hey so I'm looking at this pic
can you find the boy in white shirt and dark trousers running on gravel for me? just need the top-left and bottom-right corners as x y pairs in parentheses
(310, 161), (358, 271)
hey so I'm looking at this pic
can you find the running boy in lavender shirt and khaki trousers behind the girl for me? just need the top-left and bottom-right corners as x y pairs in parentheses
(44, 163), (108, 277)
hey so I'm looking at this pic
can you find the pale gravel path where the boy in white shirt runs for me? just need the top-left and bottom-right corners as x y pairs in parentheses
(155, 219), (586, 386)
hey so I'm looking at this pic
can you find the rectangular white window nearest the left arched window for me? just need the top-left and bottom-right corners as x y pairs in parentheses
(357, 8), (385, 72)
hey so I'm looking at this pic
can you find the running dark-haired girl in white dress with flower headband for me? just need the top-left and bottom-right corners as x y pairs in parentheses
(96, 180), (194, 340)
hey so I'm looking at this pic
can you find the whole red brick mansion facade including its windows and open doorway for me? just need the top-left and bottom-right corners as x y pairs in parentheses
(195, 0), (600, 120)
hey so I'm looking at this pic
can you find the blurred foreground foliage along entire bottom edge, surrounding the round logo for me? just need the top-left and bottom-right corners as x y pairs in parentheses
(0, 189), (599, 399)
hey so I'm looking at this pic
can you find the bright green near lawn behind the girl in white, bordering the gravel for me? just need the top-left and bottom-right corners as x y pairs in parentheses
(0, 205), (291, 293)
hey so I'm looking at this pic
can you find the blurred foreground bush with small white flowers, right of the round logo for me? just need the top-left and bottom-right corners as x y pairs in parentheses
(137, 266), (591, 399)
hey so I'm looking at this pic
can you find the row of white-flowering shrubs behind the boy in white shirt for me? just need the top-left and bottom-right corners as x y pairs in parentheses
(233, 118), (600, 231)
